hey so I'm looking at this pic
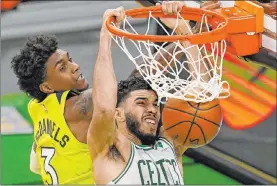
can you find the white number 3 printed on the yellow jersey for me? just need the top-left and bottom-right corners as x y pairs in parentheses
(41, 147), (59, 185)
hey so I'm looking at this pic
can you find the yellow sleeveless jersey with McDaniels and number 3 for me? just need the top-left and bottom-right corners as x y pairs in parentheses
(28, 91), (94, 184)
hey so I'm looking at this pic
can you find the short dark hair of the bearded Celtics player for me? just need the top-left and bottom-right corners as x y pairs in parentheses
(117, 76), (154, 107)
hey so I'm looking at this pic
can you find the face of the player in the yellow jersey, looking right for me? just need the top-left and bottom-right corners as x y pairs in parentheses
(43, 49), (88, 91)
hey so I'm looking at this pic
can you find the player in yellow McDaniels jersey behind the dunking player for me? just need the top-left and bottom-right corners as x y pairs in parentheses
(12, 0), (217, 184)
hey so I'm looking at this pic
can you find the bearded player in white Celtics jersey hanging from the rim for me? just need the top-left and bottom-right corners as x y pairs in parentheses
(88, 2), (208, 185)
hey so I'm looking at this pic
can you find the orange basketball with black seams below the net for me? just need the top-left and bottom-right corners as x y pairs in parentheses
(162, 99), (222, 148)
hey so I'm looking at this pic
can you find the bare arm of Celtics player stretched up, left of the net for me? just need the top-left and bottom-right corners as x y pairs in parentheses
(88, 7), (124, 159)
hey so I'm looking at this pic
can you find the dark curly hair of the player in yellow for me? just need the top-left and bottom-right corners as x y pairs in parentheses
(11, 35), (58, 101)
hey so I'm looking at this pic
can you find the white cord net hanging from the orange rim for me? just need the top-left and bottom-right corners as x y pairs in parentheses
(109, 12), (229, 103)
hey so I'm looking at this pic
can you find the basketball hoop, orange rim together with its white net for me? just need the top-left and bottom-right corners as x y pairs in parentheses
(106, 6), (229, 103)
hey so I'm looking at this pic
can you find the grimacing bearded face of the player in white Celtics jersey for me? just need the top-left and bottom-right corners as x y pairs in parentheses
(125, 90), (160, 145)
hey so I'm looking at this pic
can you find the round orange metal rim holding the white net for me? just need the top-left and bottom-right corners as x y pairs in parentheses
(106, 6), (228, 44)
